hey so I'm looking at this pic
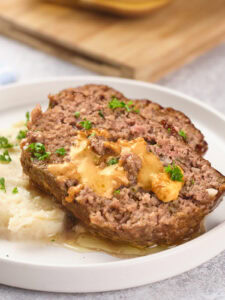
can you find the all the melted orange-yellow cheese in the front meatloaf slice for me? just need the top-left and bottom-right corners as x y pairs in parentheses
(48, 130), (183, 202)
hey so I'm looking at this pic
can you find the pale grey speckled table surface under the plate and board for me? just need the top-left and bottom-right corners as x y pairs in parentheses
(0, 36), (225, 300)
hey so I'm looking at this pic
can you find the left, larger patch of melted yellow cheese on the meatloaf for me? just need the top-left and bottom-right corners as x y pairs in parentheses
(48, 134), (129, 202)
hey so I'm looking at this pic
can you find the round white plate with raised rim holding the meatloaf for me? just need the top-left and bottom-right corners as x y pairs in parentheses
(0, 76), (225, 292)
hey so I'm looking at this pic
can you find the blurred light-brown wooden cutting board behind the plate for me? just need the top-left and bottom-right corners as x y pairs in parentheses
(0, 0), (225, 81)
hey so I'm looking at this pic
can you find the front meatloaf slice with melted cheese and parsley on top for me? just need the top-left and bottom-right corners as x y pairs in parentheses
(21, 87), (225, 245)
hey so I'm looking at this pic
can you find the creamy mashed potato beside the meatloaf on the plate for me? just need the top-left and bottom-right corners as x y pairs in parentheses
(0, 122), (65, 239)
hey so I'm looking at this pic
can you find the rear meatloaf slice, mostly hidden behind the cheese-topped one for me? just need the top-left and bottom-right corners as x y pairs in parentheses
(74, 84), (208, 155)
